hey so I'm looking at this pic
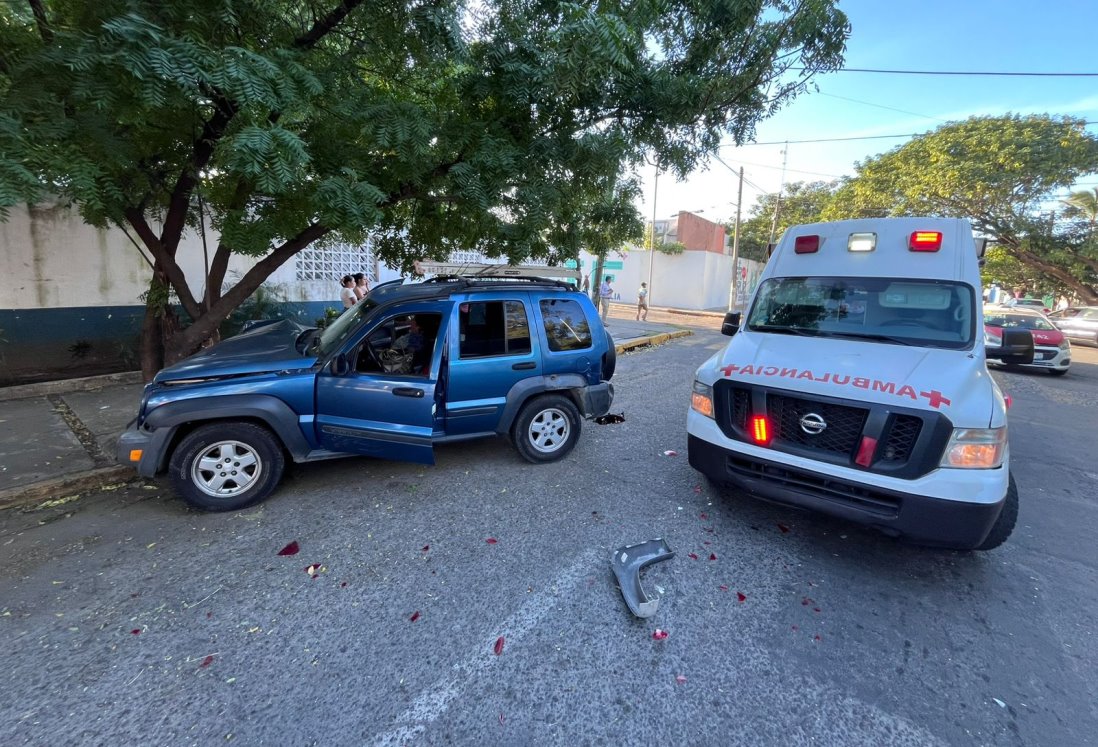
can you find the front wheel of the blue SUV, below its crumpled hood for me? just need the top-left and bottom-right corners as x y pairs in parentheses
(169, 423), (285, 511)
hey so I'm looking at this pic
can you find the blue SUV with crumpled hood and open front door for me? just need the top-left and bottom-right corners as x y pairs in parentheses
(119, 277), (616, 511)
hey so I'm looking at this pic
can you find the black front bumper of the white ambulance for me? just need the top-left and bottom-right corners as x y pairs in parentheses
(688, 436), (1002, 549)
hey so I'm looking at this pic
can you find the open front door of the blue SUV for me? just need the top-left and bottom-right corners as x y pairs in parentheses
(316, 310), (448, 465)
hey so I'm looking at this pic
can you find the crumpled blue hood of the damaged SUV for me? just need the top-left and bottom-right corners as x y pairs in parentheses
(154, 319), (316, 382)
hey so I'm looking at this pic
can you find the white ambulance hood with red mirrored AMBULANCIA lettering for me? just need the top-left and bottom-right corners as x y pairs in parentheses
(710, 332), (994, 427)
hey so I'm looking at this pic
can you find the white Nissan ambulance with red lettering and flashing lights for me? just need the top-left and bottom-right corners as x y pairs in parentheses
(686, 218), (1033, 549)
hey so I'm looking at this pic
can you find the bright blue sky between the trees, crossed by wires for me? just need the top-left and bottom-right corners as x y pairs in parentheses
(637, 0), (1098, 226)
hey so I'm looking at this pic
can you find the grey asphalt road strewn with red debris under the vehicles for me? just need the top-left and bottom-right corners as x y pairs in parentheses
(0, 330), (1098, 746)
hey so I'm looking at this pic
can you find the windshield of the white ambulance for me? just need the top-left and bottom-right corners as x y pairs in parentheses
(747, 277), (976, 349)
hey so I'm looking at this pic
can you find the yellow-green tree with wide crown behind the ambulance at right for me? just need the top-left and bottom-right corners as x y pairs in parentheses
(825, 114), (1098, 303)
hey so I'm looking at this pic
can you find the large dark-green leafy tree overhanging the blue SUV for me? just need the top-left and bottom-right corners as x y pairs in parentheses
(0, 0), (849, 376)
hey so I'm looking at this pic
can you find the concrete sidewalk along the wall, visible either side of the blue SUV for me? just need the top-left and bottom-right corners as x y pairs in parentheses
(0, 304), (708, 509)
